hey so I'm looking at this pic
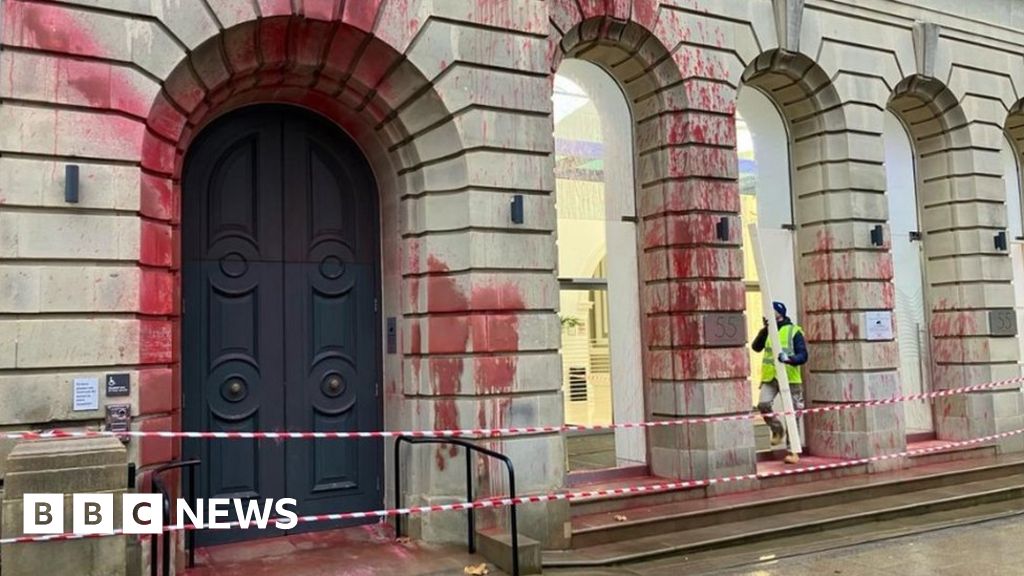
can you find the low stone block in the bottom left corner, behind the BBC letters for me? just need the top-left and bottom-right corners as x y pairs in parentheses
(0, 438), (128, 576)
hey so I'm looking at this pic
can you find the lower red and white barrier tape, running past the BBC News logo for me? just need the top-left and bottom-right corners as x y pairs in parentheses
(0, 428), (1024, 544)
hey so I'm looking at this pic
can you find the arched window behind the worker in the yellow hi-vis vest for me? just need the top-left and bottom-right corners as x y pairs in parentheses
(736, 86), (800, 450)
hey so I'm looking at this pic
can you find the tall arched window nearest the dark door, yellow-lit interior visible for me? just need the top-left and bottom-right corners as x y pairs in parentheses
(553, 59), (646, 471)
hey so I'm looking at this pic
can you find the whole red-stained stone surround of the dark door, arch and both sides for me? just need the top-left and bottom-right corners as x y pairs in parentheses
(133, 8), (467, 506)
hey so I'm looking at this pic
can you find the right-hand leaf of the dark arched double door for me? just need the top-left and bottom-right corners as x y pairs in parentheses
(285, 115), (383, 515)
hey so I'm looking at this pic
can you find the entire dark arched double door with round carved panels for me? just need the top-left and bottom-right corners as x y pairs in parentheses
(181, 106), (383, 544)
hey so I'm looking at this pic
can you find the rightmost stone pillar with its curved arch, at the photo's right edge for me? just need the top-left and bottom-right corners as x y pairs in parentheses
(889, 75), (1019, 439)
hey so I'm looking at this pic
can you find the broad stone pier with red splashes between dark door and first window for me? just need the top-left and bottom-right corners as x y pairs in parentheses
(400, 2), (568, 547)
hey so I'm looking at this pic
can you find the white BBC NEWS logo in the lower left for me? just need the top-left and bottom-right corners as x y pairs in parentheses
(23, 493), (299, 535)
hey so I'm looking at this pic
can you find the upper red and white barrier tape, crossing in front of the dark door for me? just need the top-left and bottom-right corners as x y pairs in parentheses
(0, 377), (1024, 440)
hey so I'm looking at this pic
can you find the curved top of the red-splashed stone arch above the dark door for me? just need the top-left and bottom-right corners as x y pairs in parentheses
(142, 15), (460, 208)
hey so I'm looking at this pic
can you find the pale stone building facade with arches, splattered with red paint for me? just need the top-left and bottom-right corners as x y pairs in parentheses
(0, 0), (1024, 557)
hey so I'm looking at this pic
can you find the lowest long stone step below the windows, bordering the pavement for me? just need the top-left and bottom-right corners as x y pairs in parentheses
(545, 456), (1024, 562)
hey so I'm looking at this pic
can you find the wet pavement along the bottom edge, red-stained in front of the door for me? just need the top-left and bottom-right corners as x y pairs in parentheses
(185, 508), (1024, 576)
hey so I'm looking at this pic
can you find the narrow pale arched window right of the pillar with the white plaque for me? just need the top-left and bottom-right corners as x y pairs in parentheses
(883, 111), (935, 436)
